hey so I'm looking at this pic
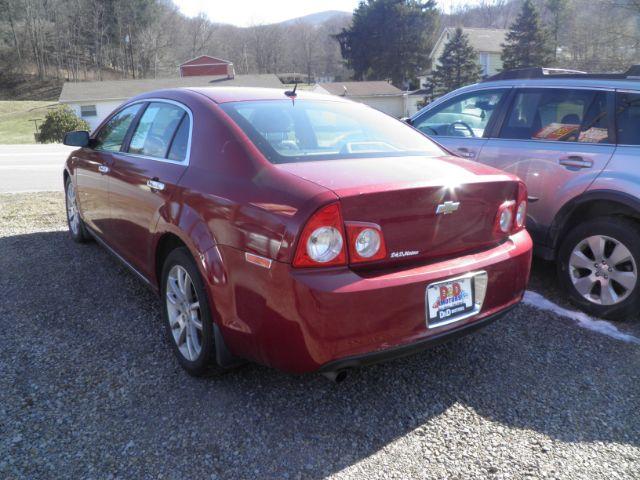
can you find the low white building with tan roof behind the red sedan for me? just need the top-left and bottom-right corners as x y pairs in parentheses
(313, 81), (406, 118)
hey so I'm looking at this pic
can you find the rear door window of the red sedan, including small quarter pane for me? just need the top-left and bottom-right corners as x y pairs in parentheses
(129, 102), (187, 158)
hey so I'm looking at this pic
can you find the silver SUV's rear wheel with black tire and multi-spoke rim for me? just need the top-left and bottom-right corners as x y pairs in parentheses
(557, 217), (640, 320)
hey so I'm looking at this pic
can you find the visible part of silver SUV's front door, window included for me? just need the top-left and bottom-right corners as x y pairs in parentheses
(411, 87), (510, 158)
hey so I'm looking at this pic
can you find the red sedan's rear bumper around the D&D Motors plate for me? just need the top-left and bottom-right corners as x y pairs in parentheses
(210, 231), (532, 373)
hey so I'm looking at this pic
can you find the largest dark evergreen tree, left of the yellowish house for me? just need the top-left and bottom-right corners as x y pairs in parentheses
(335, 0), (439, 87)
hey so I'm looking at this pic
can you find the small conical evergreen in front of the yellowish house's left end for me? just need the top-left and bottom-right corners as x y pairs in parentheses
(431, 28), (482, 95)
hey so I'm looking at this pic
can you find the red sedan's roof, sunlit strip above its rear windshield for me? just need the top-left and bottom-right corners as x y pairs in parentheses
(176, 87), (349, 103)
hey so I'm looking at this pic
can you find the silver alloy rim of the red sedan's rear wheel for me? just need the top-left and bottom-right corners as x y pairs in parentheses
(166, 265), (203, 362)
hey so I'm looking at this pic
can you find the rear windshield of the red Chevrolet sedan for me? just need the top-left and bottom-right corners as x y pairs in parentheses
(221, 99), (443, 163)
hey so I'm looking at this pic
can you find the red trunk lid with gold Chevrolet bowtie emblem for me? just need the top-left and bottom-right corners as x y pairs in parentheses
(279, 157), (518, 264)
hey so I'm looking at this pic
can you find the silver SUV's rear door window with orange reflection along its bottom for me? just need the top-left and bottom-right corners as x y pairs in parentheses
(500, 88), (609, 143)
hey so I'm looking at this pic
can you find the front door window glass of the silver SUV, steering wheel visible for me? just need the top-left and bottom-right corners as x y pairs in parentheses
(413, 89), (507, 137)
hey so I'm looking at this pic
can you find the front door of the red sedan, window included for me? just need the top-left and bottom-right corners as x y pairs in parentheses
(76, 105), (141, 237)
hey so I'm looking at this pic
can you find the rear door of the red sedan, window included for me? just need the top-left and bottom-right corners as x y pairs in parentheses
(109, 100), (192, 278)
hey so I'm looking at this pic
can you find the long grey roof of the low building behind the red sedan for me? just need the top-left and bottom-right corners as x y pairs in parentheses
(59, 73), (282, 103)
